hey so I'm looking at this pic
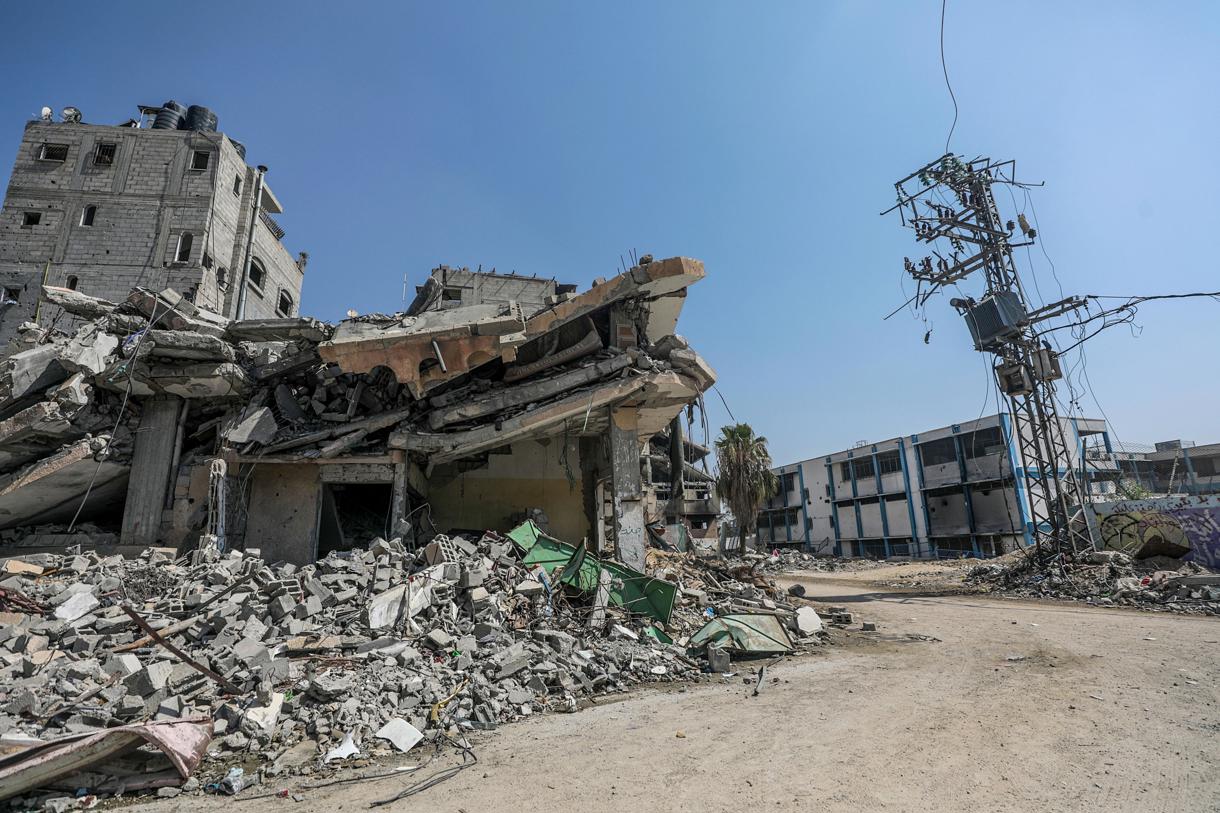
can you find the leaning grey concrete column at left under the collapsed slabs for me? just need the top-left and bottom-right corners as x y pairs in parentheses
(122, 396), (184, 546)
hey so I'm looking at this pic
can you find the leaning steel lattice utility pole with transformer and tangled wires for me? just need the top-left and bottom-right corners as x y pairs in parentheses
(883, 153), (1093, 554)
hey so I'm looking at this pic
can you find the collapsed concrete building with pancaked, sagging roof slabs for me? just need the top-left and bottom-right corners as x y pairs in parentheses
(0, 256), (717, 570)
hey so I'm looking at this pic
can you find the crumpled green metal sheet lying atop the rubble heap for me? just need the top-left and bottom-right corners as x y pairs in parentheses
(509, 520), (678, 624)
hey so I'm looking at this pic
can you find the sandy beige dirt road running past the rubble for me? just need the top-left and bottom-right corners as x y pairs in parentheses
(138, 565), (1220, 813)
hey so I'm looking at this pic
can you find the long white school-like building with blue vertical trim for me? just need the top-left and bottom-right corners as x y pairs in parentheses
(758, 414), (1118, 558)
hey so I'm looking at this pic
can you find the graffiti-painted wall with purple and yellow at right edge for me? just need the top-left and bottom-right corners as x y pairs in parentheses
(1092, 496), (1220, 568)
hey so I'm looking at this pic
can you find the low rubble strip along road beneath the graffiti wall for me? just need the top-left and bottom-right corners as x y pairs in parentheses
(965, 551), (1220, 615)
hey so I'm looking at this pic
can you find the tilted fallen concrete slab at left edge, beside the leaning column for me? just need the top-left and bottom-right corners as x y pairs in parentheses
(0, 439), (129, 529)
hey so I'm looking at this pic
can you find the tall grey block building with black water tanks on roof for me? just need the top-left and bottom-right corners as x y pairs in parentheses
(0, 103), (305, 343)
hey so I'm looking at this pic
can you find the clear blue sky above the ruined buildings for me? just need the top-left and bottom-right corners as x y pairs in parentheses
(0, 0), (1220, 463)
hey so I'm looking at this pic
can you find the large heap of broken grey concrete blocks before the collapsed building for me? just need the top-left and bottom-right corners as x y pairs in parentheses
(0, 532), (819, 800)
